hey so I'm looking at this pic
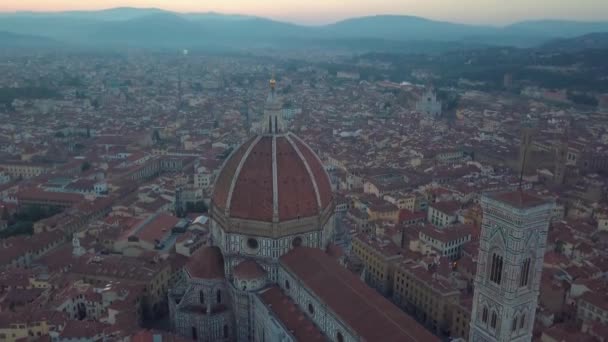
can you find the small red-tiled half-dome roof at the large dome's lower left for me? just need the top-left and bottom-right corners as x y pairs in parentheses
(186, 246), (224, 279)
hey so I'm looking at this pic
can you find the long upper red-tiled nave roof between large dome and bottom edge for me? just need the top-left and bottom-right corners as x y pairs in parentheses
(280, 247), (439, 342)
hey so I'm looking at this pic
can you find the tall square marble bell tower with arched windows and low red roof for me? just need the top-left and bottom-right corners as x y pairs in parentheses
(469, 190), (554, 342)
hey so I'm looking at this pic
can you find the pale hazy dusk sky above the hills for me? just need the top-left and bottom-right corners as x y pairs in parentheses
(0, 0), (608, 25)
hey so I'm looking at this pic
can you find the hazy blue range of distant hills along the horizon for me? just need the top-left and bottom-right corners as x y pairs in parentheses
(0, 7), (608, 52)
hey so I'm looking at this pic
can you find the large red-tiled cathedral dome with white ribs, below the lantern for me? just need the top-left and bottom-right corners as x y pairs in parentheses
(212, 133), (332, 222)
